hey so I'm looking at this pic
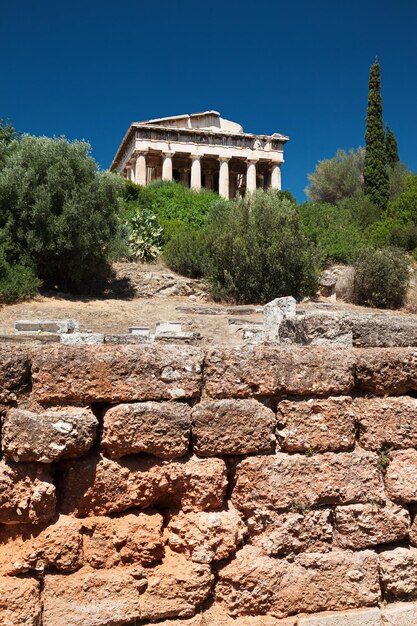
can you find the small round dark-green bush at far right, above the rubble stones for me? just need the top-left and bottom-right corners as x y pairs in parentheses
(353, 248), (409, 309)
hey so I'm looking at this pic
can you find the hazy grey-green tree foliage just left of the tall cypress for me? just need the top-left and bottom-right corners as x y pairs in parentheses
(305, 148), (365, 204)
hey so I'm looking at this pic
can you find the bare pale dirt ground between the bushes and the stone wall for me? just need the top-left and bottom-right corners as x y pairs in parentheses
(0, 263), (412, 345)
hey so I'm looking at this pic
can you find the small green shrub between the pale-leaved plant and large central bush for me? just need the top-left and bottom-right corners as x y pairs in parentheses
(164, 228), (205, 278)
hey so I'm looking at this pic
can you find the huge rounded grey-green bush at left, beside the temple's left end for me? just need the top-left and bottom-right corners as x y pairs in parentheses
(0, 135), (122, 292)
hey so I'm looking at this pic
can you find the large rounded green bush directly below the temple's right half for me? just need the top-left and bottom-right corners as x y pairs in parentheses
(205, 189), (317, 303)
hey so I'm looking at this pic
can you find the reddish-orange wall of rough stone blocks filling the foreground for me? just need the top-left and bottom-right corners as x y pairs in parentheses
(0, 345), (417, 626)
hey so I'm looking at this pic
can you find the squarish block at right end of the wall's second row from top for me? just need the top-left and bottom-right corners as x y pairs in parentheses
(354, 396), (417, 450)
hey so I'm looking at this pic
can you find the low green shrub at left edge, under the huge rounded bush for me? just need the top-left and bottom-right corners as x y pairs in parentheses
(0, 250), (41, 304)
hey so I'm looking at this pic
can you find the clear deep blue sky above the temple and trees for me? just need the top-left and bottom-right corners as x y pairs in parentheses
(0, 0), (417, 200)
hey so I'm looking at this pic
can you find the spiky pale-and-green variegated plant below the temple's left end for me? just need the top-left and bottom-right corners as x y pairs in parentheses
(127, 209), (162, 263)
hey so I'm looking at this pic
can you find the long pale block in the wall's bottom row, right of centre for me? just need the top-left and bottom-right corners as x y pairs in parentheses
(216, 546), (380, 618)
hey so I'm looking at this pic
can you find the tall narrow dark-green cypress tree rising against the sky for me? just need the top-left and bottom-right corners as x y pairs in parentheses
(364, 59), (389, 209)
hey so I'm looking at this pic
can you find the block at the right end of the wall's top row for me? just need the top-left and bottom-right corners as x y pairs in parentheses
(356, 348), (417, 396)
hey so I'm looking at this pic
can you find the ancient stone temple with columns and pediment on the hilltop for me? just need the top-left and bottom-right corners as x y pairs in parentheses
(110, 111), (288, 198)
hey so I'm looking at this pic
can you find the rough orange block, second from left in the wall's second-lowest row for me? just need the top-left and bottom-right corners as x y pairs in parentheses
(81, 510), (164, 569)
